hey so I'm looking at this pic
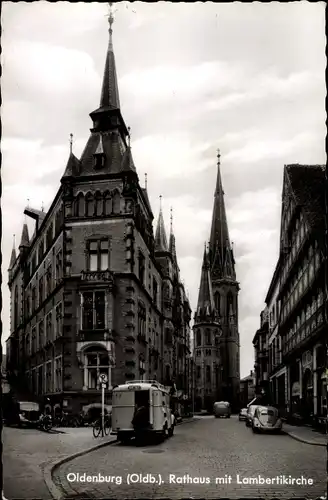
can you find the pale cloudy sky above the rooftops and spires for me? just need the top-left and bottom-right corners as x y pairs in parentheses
(1, 2), (326, 377)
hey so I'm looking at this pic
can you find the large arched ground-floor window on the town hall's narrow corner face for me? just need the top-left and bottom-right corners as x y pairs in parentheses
(84, 347), (112, 390)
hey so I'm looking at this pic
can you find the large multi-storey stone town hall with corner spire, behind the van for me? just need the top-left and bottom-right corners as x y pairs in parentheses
(7, 20), (191, 413)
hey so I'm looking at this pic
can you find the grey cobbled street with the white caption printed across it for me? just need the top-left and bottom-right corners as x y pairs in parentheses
(53, 416), (326, 499)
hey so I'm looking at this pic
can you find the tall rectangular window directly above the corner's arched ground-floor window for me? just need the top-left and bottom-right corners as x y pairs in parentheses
(82, 292), (106, 330)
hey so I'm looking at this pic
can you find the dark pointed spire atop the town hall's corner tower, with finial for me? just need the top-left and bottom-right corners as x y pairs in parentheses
(100, 2), (120, 109)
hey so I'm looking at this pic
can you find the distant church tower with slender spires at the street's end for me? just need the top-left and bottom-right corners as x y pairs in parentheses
(194, 152), (240, 409)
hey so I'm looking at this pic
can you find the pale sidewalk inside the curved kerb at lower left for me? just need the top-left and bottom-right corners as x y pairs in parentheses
(2, 427), (116, 500)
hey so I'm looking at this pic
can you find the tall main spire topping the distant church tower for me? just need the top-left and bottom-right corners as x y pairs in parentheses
(210, 150), (235, 279)
